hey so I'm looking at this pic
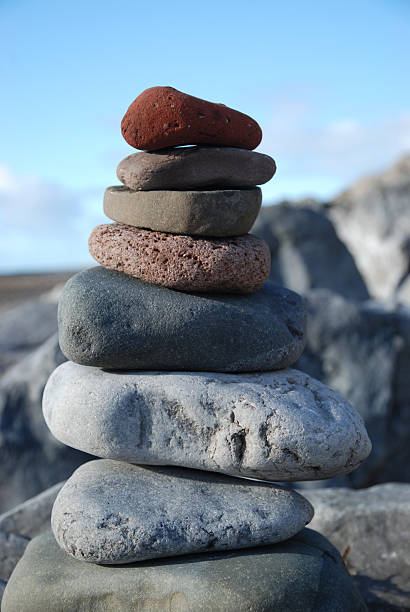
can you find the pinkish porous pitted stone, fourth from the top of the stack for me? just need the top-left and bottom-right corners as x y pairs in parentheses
(88, 223), (271, 294)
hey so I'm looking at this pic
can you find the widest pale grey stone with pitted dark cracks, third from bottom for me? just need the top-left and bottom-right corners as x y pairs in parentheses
(43, 362), (371, 481)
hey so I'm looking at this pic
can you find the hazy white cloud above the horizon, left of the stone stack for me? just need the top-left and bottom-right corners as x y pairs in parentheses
(0, 165), (104, 272)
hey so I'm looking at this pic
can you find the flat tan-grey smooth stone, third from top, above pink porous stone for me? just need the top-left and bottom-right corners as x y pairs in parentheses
(104, 184), (262, 238)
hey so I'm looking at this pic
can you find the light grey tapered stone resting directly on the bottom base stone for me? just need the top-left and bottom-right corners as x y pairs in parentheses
(51, 459), (313, 564)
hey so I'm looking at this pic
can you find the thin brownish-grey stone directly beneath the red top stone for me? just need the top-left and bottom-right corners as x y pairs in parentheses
(117, 146), (276, 191)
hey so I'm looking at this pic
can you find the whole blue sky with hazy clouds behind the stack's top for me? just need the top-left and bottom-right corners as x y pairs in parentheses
(0, 0), (410, 273)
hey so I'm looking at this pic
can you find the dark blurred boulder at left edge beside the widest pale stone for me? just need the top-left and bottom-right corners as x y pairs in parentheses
(0, 336), (87, 512)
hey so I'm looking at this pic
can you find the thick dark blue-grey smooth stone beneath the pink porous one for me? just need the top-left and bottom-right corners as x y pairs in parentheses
(58, 267), (306, 372)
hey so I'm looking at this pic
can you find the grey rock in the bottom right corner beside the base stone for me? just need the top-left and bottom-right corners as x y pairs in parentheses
(304, 483), (410, 612)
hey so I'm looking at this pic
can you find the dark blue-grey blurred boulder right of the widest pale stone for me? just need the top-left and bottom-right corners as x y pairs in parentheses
(297, 290), (410, 487)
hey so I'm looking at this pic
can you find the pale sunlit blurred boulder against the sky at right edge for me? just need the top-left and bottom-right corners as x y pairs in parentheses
(327, 155), (410, 305)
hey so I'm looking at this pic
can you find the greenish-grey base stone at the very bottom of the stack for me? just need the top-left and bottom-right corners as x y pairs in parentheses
(2, 529), (366, 612)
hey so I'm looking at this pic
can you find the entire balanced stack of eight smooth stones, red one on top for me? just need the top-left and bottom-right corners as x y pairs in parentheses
(2, 87), (370, 612)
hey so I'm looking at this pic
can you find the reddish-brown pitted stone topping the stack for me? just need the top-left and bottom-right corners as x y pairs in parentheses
(121, 87), (262, 151)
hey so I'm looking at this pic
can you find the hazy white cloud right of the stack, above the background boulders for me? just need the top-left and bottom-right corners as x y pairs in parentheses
(259, 103), (410, 198)
